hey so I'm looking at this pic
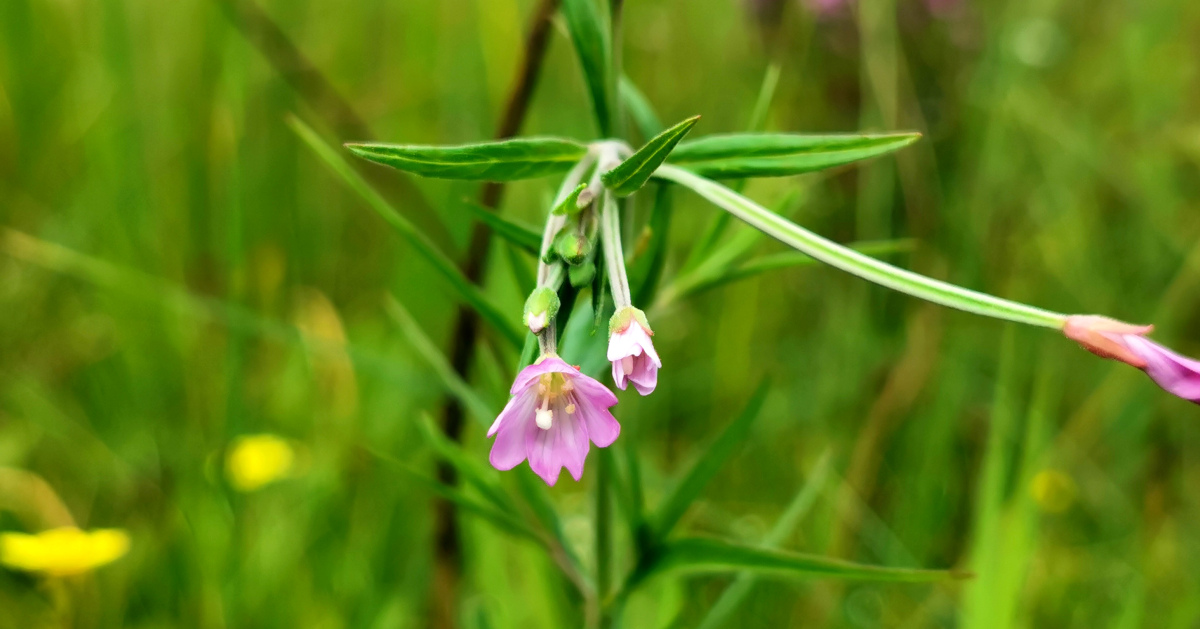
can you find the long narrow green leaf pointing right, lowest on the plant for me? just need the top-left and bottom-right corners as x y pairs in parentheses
(638, 538), (970, 582)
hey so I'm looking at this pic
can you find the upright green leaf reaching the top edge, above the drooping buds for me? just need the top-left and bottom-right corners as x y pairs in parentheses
(563, 0), (614, 138)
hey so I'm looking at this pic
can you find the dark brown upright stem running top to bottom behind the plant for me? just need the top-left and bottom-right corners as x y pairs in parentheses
(432, 0), (559, 628)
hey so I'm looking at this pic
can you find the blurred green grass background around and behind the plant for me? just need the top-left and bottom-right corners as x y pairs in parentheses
(0, 0), (1200, 628)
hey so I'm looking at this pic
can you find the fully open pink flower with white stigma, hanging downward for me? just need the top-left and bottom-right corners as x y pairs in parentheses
(487, 355), (620, 486)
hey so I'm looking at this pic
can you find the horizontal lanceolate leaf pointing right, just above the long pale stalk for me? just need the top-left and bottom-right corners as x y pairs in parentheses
(670, 133), (920, 179)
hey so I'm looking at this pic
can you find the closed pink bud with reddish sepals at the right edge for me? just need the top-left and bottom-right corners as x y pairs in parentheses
(1062, 315), (1200, 405)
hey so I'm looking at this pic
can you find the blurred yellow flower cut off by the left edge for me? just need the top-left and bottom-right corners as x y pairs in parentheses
(0, 527), (130, 576)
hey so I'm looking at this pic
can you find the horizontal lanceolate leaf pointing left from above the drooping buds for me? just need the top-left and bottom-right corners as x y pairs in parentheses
(346, 138), (588, 181)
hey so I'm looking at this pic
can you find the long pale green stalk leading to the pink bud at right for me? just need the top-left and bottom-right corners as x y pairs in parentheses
(655, 164), (1067, 328)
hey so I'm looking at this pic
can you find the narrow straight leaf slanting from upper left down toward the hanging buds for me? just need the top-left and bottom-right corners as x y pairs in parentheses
(288, 116), (524, 347)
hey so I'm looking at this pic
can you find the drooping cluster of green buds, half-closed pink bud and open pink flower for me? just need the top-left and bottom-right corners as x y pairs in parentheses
(487, 144), (662, 485)
